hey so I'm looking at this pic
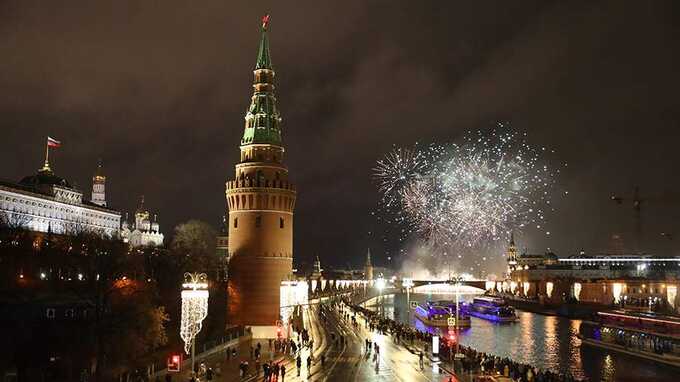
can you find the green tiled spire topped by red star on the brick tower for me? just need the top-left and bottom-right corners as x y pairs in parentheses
(241, 15), (281, 146)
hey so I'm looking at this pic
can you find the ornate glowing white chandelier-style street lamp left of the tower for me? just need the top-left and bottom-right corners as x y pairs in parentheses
(179, 272), (208, 373)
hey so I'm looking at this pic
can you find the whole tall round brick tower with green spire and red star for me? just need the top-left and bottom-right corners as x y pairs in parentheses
(226, 16), (296, 337)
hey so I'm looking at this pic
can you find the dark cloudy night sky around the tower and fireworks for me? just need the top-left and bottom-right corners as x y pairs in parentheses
(0, 0), (680, 272)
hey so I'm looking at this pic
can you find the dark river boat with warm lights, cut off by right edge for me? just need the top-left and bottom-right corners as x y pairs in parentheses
(578, 311), (680, 367)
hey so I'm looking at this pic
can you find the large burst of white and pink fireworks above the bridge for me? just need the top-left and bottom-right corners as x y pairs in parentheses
(374, 125), (559, 247)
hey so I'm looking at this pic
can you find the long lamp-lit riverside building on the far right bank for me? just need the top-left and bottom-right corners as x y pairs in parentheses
(496, 236), (680, 310)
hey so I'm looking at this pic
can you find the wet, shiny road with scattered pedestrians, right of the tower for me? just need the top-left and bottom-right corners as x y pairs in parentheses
(164, 304), (458, 382)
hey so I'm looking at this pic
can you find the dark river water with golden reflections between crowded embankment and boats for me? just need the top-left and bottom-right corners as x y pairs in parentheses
(366, 294), (680, 382)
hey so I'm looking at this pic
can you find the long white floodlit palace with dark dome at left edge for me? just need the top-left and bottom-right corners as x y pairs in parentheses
(0, 146), (121, 237)
